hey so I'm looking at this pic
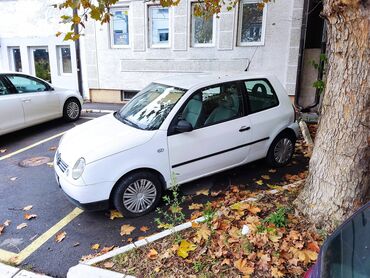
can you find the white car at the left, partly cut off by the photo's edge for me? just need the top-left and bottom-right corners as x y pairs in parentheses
(0, 73), (83, 135)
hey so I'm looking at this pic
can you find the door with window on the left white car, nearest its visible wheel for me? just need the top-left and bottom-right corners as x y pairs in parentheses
(7, 74), (60, 125)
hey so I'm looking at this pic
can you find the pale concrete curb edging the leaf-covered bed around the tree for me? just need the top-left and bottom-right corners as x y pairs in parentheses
(67, 180), (304, 278)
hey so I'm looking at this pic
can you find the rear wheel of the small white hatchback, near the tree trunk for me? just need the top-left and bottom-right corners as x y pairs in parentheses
(266, 133), (296, 167)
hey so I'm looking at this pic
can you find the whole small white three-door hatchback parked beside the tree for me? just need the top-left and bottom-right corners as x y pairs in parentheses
(54, 73), (298, 217)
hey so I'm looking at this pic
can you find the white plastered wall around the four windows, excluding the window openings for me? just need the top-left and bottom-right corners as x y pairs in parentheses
(85, 0), (303, 95)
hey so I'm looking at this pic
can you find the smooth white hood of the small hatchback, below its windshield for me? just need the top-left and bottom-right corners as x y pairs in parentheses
(58, 114), (155, 166)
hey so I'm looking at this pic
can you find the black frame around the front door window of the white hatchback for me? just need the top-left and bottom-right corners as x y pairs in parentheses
(167, 80), (248, 136)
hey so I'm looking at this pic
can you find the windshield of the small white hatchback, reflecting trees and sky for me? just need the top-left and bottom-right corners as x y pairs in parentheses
(115, 83), (186, 130)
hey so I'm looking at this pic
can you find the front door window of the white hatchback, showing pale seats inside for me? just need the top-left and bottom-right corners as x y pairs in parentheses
(180, 82), (243, 129)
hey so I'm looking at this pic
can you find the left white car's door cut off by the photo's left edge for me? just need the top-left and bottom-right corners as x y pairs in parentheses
(0, 75), (24, 135)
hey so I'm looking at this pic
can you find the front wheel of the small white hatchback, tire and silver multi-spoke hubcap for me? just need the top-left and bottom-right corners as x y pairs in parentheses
(112, 171), (162, 218)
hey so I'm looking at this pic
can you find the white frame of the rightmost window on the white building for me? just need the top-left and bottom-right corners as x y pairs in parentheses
(237, 0), (267, 46)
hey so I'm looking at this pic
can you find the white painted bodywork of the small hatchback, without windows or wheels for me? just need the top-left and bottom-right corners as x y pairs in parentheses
(55, 73), (298, 207)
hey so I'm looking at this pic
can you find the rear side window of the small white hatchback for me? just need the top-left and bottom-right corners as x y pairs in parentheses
(243, 79), (279, 113)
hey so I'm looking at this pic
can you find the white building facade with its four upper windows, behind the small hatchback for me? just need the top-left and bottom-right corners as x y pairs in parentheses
(84, 0), (304, 102)
